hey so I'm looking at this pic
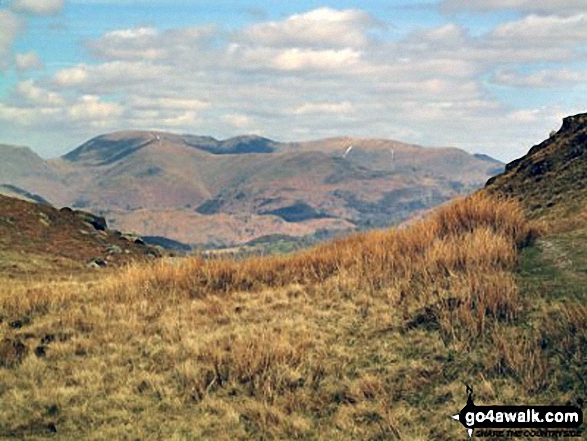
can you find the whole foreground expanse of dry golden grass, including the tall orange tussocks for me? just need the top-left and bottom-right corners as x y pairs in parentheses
(0, 195), (587, 440)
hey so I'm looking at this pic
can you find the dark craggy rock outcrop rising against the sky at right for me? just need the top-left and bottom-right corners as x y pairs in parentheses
(486, 109), (587, 216)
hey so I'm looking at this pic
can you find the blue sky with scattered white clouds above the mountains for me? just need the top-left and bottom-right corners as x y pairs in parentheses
(0, 0), (587, 162)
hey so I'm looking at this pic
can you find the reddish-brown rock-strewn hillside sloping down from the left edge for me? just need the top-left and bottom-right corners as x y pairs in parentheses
(0, 195), (158, 275)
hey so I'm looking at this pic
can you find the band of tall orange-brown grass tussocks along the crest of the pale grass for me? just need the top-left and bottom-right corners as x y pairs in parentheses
(108, 195), (539, 340)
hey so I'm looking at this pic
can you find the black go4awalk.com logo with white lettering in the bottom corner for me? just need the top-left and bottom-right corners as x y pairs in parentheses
(452, 386), (583, 438)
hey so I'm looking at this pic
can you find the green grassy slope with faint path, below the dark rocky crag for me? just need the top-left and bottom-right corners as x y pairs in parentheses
(517, 229), (587, 402)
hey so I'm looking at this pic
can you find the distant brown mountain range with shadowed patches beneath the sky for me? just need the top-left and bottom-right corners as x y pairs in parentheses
(0, 131), (503, 247)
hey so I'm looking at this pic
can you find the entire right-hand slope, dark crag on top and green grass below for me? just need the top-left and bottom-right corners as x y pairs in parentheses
(485, 114), (587, 434)
